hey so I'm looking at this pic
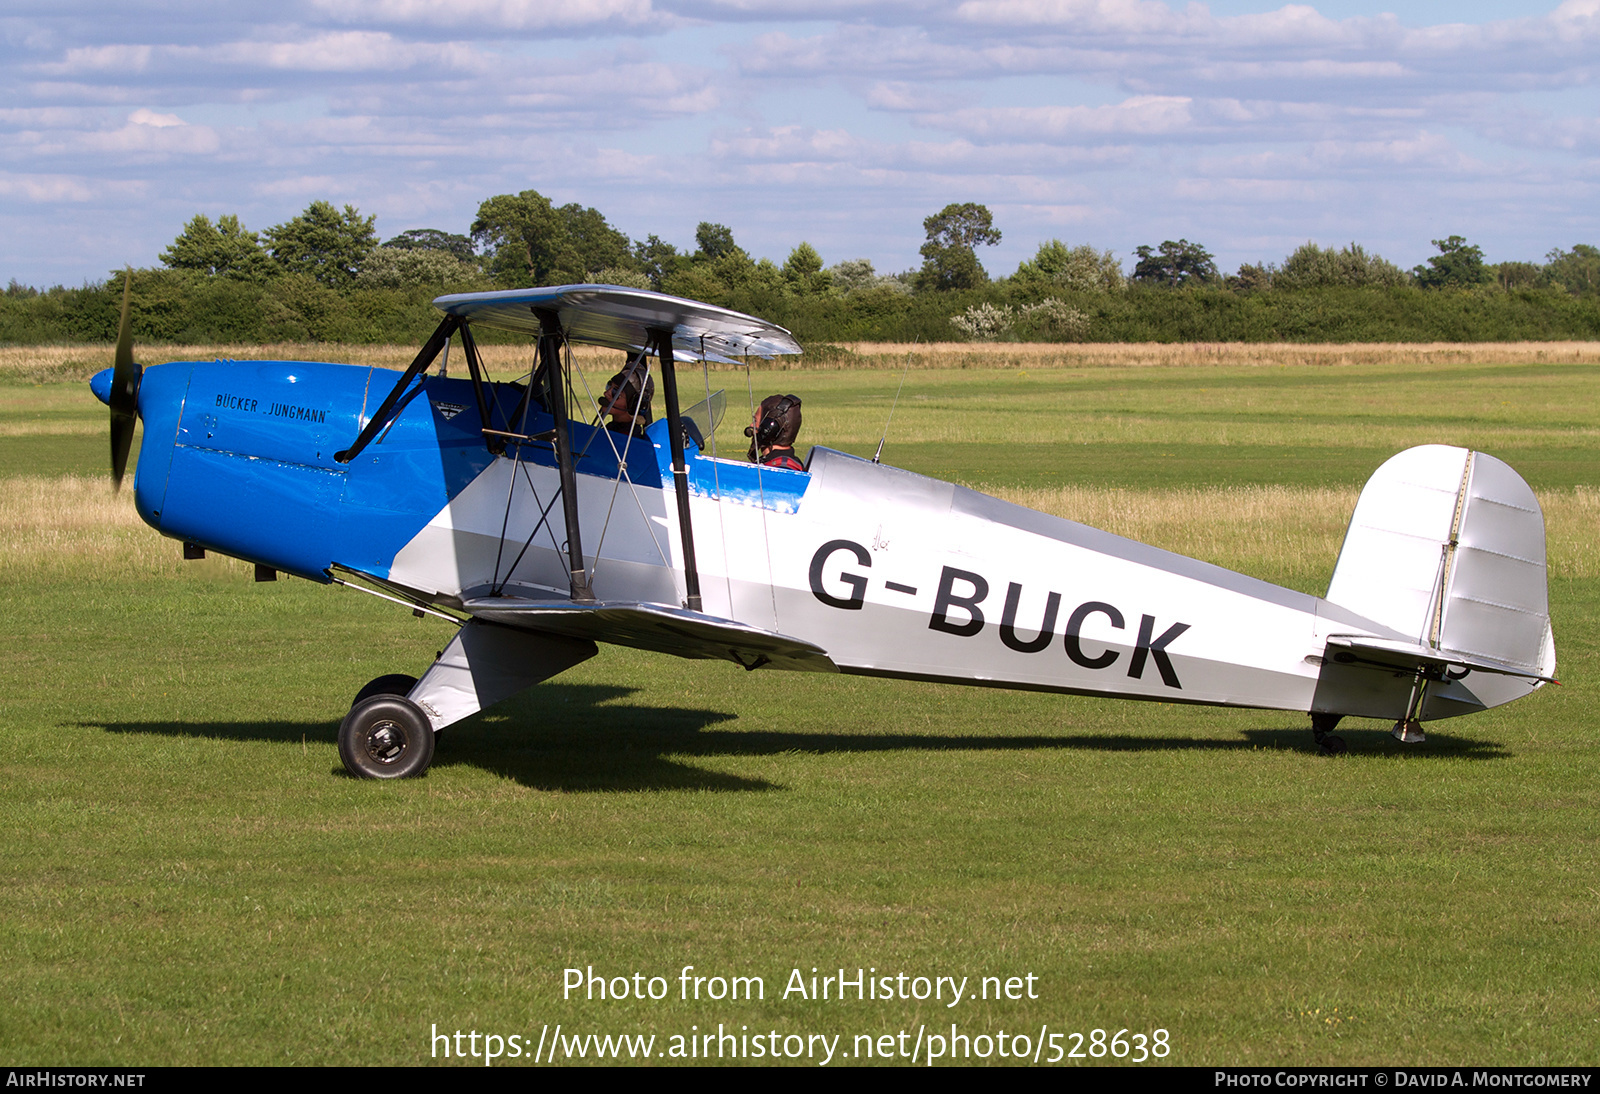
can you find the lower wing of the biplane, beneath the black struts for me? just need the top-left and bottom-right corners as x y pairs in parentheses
(462, 597), (838, 672)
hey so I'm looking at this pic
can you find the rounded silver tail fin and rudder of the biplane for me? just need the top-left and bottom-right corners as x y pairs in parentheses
(1328, 445), (1555, 678)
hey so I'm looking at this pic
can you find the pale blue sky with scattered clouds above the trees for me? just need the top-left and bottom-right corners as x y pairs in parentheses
(0, 0), (1600, 285)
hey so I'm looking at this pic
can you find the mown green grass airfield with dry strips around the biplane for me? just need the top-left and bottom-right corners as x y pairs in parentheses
(0, 347), (1600, 1065)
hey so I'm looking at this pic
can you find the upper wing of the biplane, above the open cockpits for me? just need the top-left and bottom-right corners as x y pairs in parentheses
(434, 285), (800, 361)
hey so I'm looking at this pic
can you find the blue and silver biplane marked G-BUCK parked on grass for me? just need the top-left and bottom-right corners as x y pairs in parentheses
(93, 285), (1555, 777)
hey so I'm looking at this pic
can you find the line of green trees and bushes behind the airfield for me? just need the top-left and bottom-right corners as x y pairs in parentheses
(0, 190), (1600, 342)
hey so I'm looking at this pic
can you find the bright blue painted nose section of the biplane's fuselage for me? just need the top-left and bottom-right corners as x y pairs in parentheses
(134, 361), (617, 581)
